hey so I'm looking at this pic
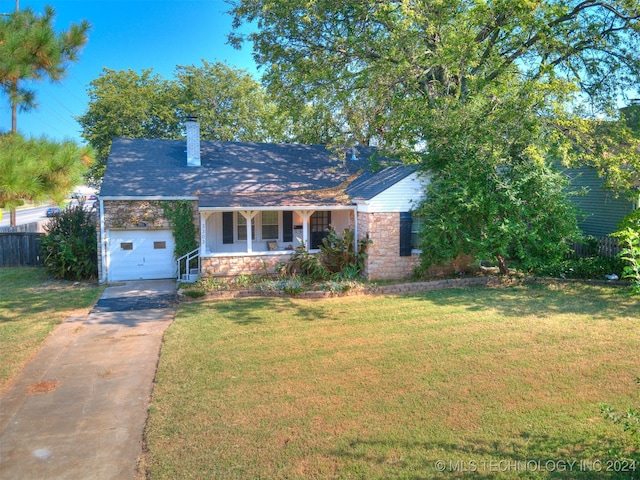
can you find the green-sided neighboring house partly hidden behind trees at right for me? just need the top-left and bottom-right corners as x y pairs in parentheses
(565, 167), (640, 237)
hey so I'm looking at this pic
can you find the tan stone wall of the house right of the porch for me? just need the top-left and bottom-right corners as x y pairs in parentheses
(358, 212), (419, 280)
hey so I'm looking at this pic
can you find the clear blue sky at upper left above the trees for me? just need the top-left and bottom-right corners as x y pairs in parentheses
(0, 0), (258, 142)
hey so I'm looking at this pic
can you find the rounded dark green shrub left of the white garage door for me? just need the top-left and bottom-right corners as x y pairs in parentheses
(40, 206), (98, 280)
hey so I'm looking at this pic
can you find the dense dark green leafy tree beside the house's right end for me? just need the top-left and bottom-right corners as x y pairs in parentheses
(414, 90), (579, 274)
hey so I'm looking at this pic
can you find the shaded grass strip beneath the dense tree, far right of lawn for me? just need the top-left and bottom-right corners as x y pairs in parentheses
(407, 284), (640, 321)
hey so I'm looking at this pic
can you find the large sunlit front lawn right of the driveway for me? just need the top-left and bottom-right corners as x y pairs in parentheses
(143, 284), (640, 479)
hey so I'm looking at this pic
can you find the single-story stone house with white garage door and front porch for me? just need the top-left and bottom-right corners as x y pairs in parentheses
(98, 121), (424, 282)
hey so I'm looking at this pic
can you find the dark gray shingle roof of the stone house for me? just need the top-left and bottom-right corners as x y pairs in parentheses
(100, 138), (413, 207)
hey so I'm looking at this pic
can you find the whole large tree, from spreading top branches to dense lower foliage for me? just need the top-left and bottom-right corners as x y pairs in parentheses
(230, 0), (640, 271)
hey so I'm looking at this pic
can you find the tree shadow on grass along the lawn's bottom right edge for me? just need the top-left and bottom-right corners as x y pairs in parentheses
(329, 435), (640, 480)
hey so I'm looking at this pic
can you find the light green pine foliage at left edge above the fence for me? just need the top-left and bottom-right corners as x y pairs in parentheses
(0, 133), (93, 226)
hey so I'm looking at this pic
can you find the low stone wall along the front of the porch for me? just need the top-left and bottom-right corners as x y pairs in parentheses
(200, 254), (291, 277)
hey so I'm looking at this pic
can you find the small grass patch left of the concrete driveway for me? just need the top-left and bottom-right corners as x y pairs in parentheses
(0, 267), (104, 387)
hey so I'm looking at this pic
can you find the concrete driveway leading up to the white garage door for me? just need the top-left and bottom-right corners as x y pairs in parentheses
(0, 280), (176, 480)
